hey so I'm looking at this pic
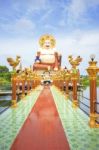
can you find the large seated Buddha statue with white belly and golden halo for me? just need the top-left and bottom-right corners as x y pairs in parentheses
(33, 35), (61, 70)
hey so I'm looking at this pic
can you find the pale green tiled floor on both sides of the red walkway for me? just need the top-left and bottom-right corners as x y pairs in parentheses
(0, 86), (99, 150)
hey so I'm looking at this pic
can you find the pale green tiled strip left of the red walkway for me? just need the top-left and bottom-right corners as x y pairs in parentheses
(0, 86), (42, 150)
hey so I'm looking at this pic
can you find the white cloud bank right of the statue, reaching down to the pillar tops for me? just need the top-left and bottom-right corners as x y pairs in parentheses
(57, 30), (99, 74)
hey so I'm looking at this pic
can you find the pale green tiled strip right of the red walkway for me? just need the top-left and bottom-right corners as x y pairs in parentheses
(51, 86), (99, 150)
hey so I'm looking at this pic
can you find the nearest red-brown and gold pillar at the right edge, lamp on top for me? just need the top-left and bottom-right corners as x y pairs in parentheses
(87, 59), (99, 128)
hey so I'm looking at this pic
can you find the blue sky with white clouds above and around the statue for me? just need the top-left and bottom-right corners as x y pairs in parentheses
(0, 0), (99, 73)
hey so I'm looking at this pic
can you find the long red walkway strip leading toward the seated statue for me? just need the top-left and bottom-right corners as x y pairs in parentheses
(11, 87), (70, 150)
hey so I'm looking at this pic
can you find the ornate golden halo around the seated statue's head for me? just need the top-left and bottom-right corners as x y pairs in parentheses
(39, 34), (56, 48)
